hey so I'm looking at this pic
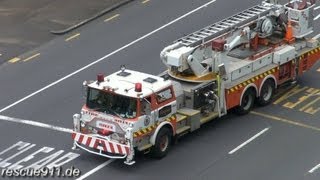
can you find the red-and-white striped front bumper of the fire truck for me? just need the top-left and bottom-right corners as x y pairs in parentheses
(72, 132), (134, 165)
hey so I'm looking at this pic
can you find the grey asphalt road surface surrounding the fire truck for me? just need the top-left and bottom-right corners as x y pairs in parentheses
(0, 0), (320, 180)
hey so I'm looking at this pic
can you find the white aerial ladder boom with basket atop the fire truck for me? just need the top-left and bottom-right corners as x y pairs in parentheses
(160, 0), (315, 82)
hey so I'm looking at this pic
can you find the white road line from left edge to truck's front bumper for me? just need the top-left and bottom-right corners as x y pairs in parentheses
(0, 115), (73, 133)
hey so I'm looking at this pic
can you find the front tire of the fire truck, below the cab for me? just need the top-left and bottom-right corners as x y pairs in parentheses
(151, 127), (172, 159)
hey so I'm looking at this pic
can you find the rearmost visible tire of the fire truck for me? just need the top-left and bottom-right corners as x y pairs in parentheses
(258, 79), (275, 106)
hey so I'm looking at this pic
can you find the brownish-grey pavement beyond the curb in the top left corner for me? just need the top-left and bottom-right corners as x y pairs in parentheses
(0, 0), (121, 64)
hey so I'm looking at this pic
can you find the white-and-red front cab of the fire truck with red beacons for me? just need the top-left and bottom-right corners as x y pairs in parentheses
(72, 68), (177, 164)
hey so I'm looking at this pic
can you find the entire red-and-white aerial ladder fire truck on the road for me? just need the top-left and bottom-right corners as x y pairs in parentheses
(72, 0), (320, 165)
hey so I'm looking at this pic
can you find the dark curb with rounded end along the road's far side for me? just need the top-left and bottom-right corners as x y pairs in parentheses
(50, 0), (134, 35)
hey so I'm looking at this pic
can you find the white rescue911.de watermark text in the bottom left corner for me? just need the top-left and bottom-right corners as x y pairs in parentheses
(1, 166), (81, 177)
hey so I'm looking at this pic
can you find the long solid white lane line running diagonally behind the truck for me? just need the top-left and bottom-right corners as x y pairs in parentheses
(0, 0), (216, 113)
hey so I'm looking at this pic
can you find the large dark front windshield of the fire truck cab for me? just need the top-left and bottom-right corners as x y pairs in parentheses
(87, 88), (137, 118)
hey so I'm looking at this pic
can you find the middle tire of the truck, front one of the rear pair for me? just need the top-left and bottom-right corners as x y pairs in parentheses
(235, 88), (256, 115)
